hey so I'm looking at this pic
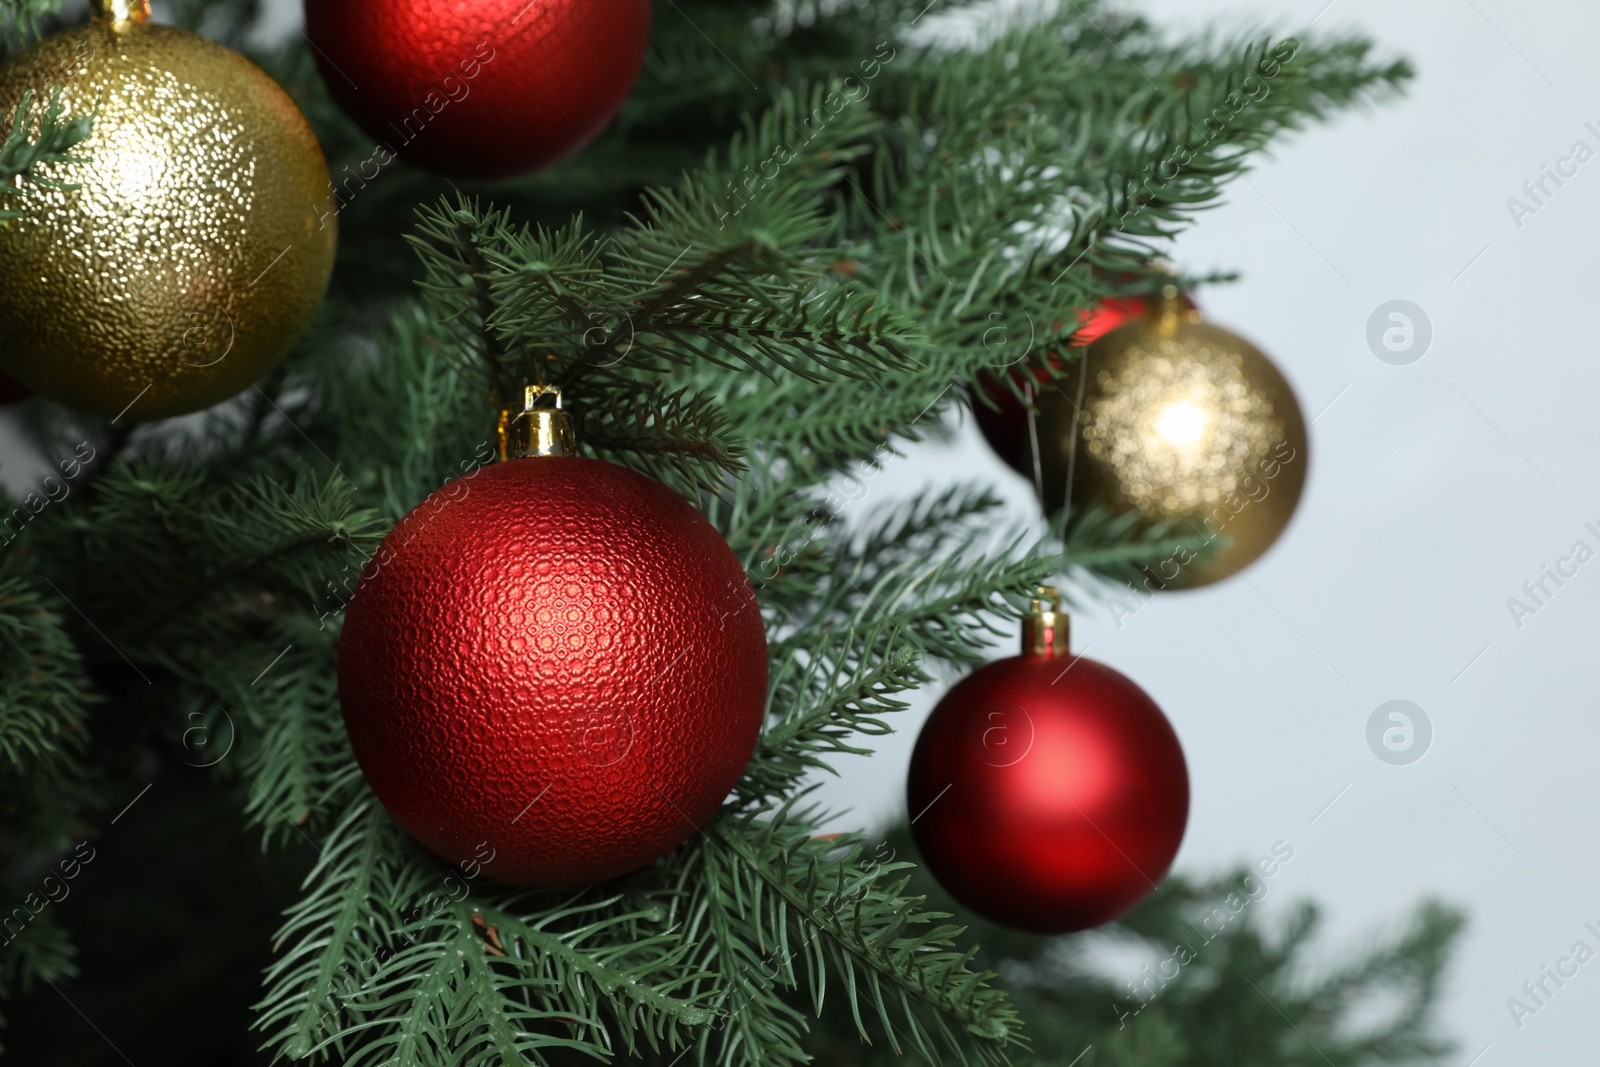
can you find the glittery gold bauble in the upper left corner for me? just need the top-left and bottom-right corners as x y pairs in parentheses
(0, 0), (334, 419)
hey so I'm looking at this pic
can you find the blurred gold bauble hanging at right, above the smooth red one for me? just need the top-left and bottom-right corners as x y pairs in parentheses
(1038, 286), (1309, 589)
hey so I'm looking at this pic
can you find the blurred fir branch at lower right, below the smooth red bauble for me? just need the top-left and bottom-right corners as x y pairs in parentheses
(825, 822), (1461, 1067)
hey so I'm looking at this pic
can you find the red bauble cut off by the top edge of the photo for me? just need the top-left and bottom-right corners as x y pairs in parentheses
(306, 0), (650, 178)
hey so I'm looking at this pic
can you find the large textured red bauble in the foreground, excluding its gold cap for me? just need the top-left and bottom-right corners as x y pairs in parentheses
(339, 456), (766, 886)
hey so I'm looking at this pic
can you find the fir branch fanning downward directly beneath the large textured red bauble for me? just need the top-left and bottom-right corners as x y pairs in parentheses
(275, 845), (712, 1067)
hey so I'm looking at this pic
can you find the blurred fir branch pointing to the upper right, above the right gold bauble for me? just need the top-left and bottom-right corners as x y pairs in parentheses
(838, 12), (1410, 363)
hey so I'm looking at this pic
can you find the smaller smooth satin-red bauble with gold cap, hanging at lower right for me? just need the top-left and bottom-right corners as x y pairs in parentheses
(907, 589), (1189, 934)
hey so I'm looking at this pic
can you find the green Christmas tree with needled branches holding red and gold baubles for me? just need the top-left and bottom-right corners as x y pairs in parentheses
(0, 0), (1461, 1067)
